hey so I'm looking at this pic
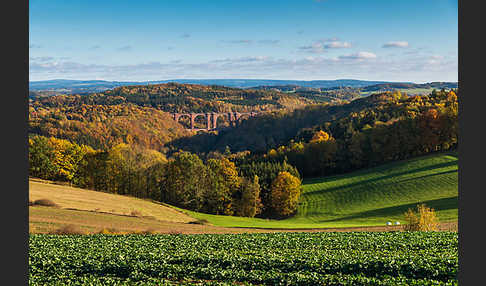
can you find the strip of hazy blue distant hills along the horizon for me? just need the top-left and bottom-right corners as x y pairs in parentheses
(29, 79), (458, 102)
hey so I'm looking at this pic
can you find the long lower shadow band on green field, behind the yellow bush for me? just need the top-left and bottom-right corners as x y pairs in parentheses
(319, 197), (459, 223)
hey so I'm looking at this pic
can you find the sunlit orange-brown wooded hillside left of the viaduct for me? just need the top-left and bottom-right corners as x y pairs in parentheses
(29, 103), (189, 151)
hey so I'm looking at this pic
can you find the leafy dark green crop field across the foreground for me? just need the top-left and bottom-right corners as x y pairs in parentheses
(29, 232), (458, 285)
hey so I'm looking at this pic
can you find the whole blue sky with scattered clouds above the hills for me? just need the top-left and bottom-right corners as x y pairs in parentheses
(29, 0), (458, 83)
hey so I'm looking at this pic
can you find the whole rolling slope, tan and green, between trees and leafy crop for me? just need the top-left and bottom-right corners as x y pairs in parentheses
(29, 153), (458, 233)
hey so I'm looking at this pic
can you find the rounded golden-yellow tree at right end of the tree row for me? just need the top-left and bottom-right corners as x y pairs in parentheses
(270, 171), (302, 216)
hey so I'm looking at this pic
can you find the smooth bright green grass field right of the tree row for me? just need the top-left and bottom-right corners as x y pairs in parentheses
(180, 153), (458, 229)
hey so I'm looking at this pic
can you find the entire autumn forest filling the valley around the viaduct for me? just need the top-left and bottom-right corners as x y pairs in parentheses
(29, 84), (458, 218)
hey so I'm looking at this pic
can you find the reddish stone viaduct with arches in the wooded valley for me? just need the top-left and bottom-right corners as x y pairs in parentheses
(171, 112), (258, 131)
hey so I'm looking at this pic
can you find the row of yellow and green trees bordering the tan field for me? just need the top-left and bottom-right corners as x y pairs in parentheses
(29, 135), (301, 218)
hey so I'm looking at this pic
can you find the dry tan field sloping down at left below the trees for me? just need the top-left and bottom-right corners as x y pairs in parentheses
(29, 179), (270, 233)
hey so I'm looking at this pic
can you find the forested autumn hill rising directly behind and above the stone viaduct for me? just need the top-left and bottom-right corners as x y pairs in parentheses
(66, 83), (320, 112)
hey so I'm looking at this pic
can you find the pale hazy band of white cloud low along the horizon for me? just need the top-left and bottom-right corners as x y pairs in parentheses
(29, 52), (457, 82)
